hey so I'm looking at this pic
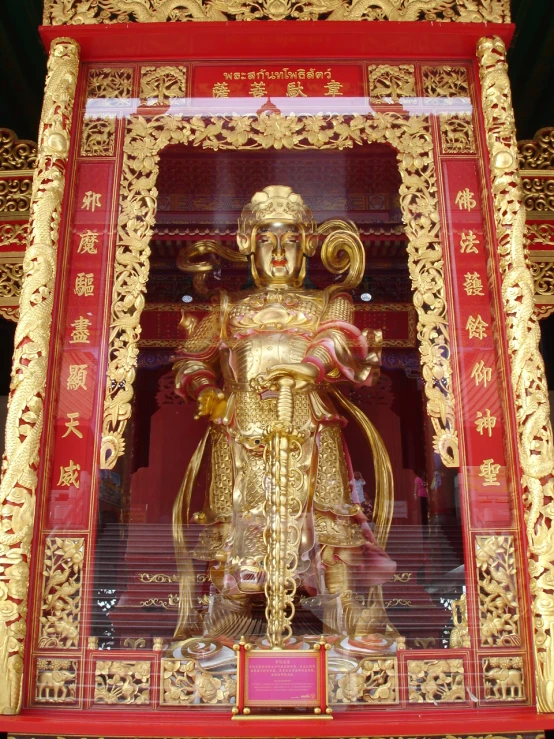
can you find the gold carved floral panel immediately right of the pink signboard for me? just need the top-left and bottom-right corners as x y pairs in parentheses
(329, 657), (398, 705)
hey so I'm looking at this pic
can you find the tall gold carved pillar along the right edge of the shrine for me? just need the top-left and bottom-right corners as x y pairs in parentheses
(477, 37), (554, 712)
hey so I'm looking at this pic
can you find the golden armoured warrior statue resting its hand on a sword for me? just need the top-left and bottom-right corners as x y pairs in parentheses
(173, 186), (396, 646)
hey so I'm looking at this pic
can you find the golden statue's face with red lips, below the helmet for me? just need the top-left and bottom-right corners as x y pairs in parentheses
(253, 222), (304, 286)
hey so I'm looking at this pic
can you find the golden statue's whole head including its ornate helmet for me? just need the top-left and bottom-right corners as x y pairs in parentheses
(237, 185), (318, 287)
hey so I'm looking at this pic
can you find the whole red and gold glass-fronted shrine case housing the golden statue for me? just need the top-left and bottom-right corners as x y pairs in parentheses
(0, 11), (552, 736)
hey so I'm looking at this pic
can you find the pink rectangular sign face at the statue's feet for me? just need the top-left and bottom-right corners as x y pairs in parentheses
(244, 650), (321, 707)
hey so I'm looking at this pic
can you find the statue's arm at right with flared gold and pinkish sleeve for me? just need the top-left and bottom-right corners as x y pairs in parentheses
(303, 293), (382, 385)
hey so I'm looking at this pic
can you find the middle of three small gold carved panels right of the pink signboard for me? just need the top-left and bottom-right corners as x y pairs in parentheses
(406, 659), (466, 703)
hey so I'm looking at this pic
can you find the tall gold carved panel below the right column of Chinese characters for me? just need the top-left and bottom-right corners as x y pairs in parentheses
(475, 536), (521, 647)
